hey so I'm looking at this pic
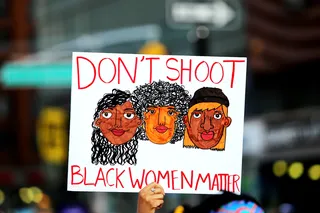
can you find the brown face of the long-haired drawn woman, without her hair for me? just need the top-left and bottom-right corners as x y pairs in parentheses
(95, 101), (141, 145)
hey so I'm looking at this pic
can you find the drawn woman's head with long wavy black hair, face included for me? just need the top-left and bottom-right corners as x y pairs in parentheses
(91, 89), (141, 165)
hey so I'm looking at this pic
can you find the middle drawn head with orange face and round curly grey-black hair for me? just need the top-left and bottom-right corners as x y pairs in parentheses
(132, 80), (191, 144)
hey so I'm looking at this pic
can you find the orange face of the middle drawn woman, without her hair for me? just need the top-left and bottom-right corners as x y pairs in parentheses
(144, 106), (179, 144)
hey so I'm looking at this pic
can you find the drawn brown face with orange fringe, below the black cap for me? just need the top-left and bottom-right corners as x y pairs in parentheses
(184, 103), (231, 149)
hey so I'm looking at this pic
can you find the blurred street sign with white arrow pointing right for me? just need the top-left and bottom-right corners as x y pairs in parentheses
(166, 0), (242, 30)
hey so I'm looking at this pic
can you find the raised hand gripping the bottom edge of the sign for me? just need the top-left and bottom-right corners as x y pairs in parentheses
(137, 183), (165, 213)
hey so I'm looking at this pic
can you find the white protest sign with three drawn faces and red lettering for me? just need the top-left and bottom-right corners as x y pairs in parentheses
(68, 52), (247, 194)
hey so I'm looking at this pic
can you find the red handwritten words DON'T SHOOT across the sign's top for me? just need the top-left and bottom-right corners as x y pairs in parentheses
(75, 55), (245, 90)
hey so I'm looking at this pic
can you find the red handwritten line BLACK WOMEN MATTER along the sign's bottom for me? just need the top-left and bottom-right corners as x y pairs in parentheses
(70, 165), (240, 192)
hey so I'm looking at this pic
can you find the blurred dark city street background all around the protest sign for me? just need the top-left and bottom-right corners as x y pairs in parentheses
(0, 0), (320, 213)
